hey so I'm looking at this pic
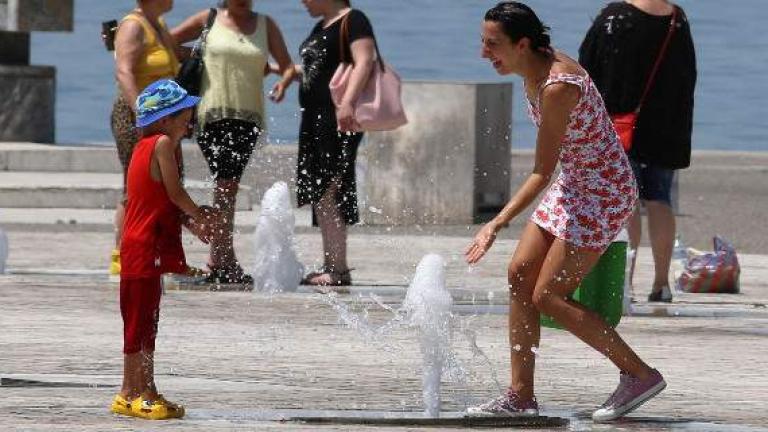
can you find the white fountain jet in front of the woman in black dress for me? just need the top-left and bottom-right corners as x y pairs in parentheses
(253, 182), (304, 292)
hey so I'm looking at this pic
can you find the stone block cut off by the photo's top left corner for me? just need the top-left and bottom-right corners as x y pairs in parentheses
(0, 0), (75, 32)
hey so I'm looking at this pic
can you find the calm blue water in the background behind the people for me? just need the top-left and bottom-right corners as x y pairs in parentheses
(32, 0), (768, 151)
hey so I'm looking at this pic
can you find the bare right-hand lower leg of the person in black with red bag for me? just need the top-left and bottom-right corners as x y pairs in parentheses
(645, 201), (675, 292)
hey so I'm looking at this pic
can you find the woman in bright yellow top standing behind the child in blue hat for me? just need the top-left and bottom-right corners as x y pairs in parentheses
(109, 0), (179, 275)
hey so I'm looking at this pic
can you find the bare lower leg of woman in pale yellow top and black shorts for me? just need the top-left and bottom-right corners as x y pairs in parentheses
(210, 180), (239, 268)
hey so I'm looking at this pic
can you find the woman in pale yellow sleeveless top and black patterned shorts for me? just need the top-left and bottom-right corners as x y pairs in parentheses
(172, 0), (295, 284)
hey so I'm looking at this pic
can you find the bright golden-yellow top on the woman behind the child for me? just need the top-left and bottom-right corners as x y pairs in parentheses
(123, 13), (179, 92)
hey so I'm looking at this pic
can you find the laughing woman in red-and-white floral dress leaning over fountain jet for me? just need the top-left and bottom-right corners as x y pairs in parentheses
(465, 1), (666, 421)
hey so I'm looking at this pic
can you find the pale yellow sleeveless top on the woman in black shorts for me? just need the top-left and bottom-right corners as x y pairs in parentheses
(198, 14), (269, 129)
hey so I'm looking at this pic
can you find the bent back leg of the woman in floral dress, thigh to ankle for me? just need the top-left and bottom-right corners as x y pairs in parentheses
(533, 239), (652, 379)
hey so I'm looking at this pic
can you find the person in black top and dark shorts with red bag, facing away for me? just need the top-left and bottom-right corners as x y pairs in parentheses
(579, 0), (696, 302)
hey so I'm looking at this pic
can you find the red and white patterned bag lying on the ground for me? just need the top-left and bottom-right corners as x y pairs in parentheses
(677, 237), (741, 294)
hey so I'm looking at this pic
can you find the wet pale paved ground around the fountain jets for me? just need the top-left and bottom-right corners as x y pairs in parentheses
(0, 231), (768, 432)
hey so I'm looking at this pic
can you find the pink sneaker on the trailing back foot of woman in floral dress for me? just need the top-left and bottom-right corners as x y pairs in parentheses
(592, 369), (667, 422)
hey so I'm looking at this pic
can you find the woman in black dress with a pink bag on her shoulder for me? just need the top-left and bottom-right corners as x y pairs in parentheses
(297, 0), (375, 286)
